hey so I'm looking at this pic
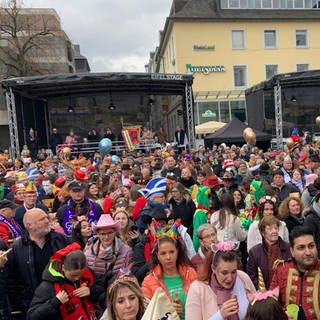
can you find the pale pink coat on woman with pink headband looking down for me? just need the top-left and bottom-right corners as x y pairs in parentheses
(186, 270), (256, 320)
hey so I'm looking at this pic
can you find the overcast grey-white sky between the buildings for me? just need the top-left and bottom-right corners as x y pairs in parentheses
(24, 0), (172, 72)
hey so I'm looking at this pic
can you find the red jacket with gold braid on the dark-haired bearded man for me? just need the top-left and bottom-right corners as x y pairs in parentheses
(270, 259), (320, 320)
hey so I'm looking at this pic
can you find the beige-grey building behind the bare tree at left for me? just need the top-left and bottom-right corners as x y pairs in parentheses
(0, 8), (76, 149)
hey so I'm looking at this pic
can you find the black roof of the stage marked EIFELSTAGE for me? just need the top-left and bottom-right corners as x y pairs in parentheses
(1, 73), (193, 99)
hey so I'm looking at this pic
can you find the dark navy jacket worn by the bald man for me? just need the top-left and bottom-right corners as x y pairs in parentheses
(8, 231), (68, 312)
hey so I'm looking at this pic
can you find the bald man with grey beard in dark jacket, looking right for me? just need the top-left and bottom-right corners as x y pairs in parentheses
(8, 208), (68, 315)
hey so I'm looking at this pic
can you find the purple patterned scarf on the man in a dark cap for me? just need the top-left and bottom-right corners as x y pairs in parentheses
(63, 197), (99, 236)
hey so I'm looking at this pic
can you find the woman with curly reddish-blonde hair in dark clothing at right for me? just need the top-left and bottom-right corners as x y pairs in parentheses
(278, 197), (304, 233)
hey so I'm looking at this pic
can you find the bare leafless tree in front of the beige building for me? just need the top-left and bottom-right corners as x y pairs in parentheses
(0, 0), (58, 78)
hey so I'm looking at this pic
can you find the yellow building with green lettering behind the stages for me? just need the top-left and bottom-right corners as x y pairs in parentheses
(149, 0), (320, 139)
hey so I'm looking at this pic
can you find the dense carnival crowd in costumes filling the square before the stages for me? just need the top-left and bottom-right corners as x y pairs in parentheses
(0, 137), (320, 320)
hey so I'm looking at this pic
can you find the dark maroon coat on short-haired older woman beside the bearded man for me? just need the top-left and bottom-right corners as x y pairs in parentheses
(247, 238), (291, 289)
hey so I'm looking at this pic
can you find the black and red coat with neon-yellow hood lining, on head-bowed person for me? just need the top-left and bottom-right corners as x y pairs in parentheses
(27, 266), (104, 320)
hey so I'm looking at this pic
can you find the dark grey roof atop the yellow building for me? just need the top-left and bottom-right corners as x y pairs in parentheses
(169, 0), (320, 21)
